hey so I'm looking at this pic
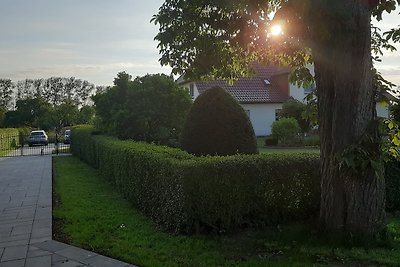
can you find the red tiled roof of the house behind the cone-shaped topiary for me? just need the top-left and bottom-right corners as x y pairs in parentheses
(192, 63), (289, 104)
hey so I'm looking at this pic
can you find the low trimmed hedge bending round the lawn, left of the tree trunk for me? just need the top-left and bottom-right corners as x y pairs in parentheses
(71, 126), (319, 232)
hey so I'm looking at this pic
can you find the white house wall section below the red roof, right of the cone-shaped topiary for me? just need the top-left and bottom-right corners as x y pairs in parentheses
(241, 104), (282, 136)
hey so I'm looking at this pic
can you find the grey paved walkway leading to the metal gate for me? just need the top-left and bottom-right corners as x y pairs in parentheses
(0, 156), (138, 267)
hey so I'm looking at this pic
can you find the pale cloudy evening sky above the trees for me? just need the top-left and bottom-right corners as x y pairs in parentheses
(0, 0), (400, 85)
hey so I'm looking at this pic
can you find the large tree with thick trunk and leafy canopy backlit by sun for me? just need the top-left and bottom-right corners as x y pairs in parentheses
(153, 0), (400, 239)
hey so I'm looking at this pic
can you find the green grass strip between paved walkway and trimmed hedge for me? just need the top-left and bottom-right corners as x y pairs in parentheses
(53, 157), (400, 267)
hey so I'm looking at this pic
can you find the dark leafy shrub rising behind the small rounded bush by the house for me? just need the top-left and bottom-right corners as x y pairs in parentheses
(279, 99), (311, 133)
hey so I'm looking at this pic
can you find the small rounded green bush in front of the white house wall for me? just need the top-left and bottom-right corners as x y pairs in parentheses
(271, 118), (300, 145)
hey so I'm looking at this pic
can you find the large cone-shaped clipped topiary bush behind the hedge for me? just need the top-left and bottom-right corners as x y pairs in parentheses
(181, 87), (258, 156)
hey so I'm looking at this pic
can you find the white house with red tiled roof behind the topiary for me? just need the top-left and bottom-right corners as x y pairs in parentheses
(177, 63), (305, 136)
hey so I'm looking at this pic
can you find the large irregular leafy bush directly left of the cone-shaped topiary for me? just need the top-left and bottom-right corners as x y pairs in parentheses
(94, 73), (191, 145)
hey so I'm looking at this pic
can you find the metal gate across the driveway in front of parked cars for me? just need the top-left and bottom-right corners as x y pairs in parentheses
(0, 134), (70, 157)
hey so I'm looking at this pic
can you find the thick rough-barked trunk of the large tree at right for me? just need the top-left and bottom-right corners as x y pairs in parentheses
(313, 0), (385, 239)
